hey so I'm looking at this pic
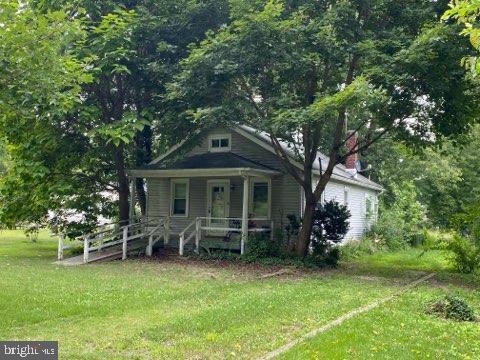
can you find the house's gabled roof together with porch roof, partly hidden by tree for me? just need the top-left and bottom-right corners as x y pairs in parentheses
(141, 125), (383, 191)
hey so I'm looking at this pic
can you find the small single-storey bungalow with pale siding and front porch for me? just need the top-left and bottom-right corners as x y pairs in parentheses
(128, 125), (382, 254)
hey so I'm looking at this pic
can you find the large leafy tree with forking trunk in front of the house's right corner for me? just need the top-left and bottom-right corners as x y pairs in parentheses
(170, 0), (476, 256)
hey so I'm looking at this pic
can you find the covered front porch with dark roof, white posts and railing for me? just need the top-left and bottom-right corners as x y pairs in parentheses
(129, 153), (280, 255)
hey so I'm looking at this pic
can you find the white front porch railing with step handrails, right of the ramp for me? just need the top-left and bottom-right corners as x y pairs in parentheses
(178, 217), (273, 256)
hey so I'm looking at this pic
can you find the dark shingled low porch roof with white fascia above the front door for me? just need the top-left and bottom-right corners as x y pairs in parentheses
(129, 152), (280, 177)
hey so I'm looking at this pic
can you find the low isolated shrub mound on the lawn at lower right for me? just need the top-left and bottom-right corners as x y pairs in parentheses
(425, 295), (477, 321)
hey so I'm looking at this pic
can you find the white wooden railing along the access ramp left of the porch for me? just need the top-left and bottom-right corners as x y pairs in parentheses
(57, 217), (170, 263)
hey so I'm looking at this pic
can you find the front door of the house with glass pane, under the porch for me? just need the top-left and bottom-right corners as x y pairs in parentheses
(207, 180), (230, 236)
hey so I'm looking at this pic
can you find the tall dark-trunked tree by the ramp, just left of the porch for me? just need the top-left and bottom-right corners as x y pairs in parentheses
(67, 0), (229, 221)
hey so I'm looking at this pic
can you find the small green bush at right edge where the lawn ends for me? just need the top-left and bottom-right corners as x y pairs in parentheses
(447, 235), (480, 274)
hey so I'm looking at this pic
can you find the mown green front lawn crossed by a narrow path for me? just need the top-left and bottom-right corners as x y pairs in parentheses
(0, 231), (480, 359)
